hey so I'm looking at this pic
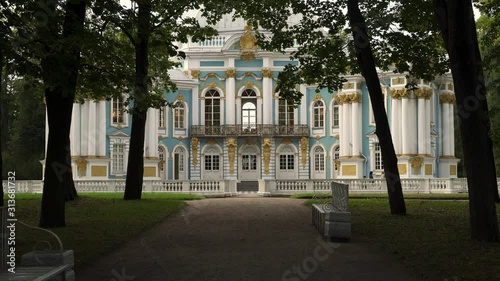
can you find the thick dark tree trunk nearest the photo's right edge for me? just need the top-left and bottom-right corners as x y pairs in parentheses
(434, 0), (500, 242)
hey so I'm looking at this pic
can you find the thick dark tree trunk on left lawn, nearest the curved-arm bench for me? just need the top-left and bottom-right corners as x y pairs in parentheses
(40, 0), (87, 227)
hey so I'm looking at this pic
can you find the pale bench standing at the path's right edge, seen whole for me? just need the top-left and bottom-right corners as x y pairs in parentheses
(312, 182), (352, 240)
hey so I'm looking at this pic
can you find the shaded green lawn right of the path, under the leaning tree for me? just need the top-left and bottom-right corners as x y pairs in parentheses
(305, 198), (500, 281)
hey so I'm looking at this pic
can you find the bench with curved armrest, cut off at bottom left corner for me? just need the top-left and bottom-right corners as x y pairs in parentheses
(0, 207), (75, 281)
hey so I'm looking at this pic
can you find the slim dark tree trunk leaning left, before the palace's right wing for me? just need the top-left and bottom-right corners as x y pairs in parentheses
(347, 0), (406, 215)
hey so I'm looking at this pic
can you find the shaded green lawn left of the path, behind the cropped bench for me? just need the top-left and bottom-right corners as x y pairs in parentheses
(9, 193), (203, 270)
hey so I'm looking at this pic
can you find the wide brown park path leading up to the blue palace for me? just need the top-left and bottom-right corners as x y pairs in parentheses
(76, 197), (426, 281)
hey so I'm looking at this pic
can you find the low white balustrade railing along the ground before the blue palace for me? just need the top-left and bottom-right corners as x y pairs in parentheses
(2, 178), (500, 194)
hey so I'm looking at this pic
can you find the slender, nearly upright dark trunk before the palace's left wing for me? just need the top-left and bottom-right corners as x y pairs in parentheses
(123, 0), (152, 200)
